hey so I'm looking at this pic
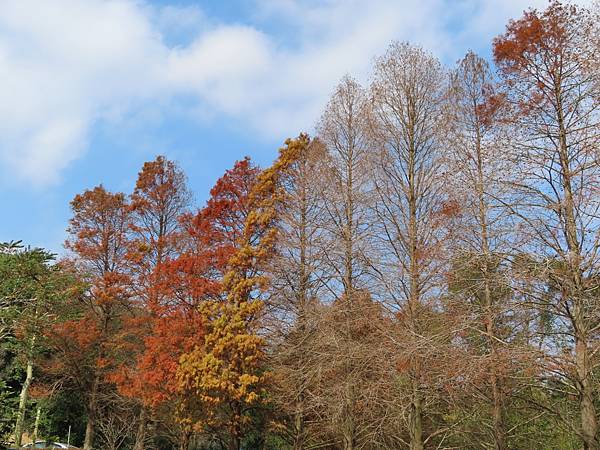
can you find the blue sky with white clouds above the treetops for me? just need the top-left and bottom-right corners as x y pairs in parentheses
(0, 0), (584, 254)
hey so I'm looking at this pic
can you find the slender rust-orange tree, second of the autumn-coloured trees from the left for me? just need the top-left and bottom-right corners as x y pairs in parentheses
(112, 156), (191, 450)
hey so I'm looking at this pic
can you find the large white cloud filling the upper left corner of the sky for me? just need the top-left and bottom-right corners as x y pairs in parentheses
(0, 0), (167, 185)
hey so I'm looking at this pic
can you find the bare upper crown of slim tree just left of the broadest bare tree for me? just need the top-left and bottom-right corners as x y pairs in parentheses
(317, 77), (371, 296)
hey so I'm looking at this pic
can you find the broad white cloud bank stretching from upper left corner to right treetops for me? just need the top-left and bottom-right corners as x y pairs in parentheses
(0, 0), (584, 185)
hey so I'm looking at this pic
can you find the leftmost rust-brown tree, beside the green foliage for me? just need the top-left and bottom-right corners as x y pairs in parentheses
(61, 186), (131, 450)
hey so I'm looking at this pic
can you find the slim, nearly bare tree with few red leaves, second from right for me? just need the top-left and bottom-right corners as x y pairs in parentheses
(445, 52), (512, 450)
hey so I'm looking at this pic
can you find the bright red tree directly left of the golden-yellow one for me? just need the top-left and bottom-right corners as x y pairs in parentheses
(111, 158), (259, 446)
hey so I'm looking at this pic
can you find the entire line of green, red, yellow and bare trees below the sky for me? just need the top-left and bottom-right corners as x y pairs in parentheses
(0, 0), (600, 450)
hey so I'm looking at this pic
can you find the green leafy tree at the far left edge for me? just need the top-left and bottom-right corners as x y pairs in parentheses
(0, 241), (80, 438)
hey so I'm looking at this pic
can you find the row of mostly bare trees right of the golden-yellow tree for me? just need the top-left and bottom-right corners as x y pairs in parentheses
(265, 1), (600, 450)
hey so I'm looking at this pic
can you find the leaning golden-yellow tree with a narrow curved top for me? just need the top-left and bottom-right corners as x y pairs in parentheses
(178, 134), (310, 450)
